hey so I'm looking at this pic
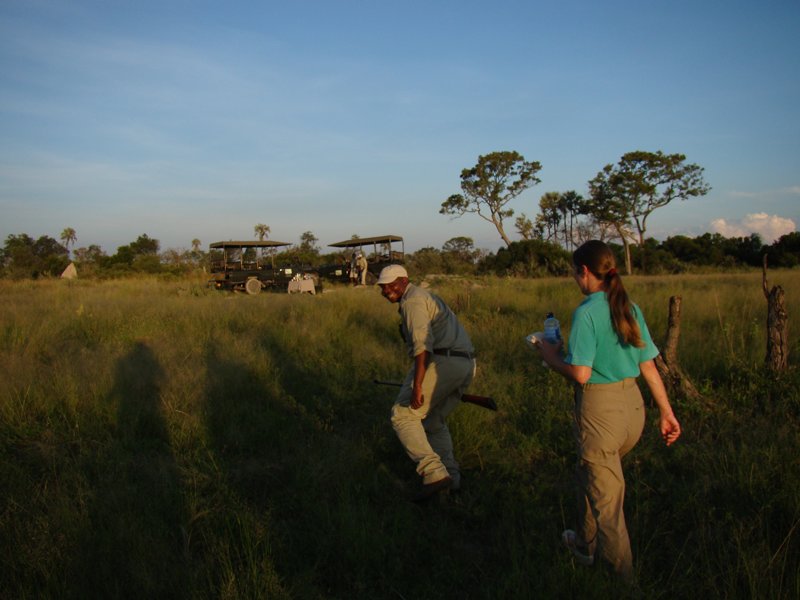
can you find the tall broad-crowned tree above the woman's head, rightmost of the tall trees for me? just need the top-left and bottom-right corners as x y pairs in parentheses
(589, 150), (711, 272)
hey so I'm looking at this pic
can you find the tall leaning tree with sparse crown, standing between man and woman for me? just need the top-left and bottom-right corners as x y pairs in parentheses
(439, 151), (542, 246)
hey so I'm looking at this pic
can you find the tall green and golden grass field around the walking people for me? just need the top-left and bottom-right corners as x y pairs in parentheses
(0, 270), (800, 600)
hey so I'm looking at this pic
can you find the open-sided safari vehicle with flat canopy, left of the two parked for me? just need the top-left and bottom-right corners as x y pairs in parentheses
(208, 240), (319, 294)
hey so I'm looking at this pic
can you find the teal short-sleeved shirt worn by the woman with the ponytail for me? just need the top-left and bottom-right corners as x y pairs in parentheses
(565, 291), (658, 383)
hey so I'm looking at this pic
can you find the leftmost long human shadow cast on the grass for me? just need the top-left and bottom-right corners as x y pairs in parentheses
(74, 341), (188, 598)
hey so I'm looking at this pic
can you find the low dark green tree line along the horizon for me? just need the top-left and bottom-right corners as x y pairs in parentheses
(0, 231), (800, 279)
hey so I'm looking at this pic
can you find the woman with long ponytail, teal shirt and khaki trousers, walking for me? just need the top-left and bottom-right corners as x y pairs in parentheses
(537, 240), (681, 583)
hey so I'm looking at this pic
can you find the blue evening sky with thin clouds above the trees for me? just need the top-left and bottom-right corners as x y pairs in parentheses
(0, 0), (800, 254)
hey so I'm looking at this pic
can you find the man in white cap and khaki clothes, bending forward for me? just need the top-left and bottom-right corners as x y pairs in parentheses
(378, 265), (475, 501)
